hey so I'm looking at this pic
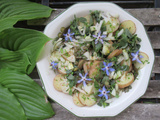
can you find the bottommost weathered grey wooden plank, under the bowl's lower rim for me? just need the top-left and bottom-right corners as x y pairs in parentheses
(47, 103), (160, 120)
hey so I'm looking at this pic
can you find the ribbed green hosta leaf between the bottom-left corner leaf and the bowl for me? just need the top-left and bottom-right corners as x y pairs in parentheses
(0, 69), (54, 120)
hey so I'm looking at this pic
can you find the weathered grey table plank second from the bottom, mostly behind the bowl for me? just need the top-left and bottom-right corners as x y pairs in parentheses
(34, 79), (160, 98)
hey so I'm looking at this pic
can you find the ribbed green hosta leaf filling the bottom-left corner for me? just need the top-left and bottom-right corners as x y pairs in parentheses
(0, 84), (26, 120)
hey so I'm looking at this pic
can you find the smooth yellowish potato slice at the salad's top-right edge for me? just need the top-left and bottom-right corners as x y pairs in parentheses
(120, 20), (136, 34)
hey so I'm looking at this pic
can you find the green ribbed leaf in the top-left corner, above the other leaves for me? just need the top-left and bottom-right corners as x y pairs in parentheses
(0, 0), (52, 31)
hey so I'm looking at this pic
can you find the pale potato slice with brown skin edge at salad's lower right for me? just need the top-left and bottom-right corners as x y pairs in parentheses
(117, 73), (134, 88)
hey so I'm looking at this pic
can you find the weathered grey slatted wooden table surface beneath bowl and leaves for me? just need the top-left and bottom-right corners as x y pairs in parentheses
(28, 8), (160, 120)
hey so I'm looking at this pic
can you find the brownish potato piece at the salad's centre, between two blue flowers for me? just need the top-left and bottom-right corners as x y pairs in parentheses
(89, 61), (101, 78)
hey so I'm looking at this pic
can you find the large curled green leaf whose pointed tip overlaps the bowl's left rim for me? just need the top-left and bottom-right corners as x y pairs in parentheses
(0, 28), (50, 74)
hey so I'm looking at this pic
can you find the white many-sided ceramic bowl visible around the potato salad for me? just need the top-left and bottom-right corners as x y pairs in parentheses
(37, 2), (154, 117)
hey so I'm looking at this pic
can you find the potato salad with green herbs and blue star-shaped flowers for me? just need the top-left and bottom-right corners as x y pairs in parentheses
(50, 10), (149, 107)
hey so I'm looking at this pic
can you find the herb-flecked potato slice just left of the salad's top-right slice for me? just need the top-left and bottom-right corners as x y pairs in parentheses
(106, 17), (120, 33)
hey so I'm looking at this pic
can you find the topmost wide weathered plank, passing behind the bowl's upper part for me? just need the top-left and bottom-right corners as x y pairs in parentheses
(28, 8), (160, 26)
